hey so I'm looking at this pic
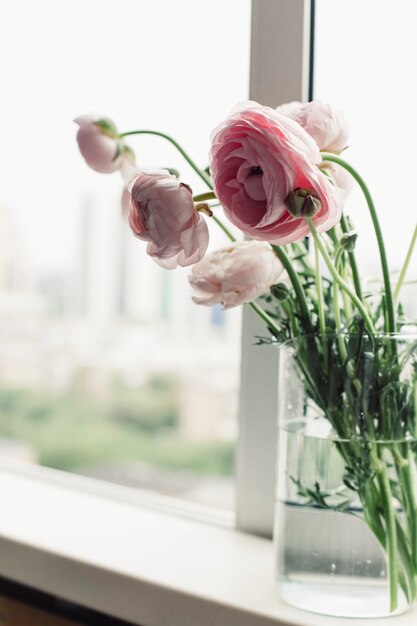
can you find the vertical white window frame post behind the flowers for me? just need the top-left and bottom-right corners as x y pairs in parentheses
(236, 0), (314, 536)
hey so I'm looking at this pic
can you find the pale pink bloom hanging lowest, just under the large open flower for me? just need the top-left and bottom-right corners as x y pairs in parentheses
(188, 241), (283, 309)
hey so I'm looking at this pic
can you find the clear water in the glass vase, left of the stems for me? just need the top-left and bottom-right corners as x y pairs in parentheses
(275, 419), (408, 617)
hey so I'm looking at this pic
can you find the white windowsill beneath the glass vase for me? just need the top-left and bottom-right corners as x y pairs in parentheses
(0, 470), (416, 626)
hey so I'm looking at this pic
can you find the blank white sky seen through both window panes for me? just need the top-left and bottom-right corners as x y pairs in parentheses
(0, 0), (417, 282)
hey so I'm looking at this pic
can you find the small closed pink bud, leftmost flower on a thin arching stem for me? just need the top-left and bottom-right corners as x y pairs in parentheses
(74, 114), (134, 174)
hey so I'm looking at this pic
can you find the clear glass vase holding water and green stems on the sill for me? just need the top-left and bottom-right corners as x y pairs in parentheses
(274, 335), (417, 617)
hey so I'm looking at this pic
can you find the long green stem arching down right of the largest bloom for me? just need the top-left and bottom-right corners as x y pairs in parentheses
(321, 152), (396, 333)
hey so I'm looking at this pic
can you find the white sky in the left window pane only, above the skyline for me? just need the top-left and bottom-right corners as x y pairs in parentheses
(0, 0), (250, 269)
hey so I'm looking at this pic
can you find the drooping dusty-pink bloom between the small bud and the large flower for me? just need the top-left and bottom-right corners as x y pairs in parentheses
(129, 170), (209, 269)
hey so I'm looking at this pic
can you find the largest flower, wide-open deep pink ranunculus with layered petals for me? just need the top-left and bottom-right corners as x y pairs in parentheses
(210, 102), (345, 245)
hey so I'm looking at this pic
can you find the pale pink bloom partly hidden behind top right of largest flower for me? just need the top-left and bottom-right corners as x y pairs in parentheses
(276, 100), (349, 154)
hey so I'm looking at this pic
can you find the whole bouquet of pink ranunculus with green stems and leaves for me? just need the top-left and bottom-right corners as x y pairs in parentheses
(75, 101), (417, 611)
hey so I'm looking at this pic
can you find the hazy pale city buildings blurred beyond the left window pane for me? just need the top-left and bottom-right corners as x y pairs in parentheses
(0, 193), (240, 440)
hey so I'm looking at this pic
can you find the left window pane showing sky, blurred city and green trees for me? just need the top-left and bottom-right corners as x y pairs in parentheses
(0, 0), (250, 507)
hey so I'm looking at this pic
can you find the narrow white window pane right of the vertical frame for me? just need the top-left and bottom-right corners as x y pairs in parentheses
(314, 0), (417, 316)
